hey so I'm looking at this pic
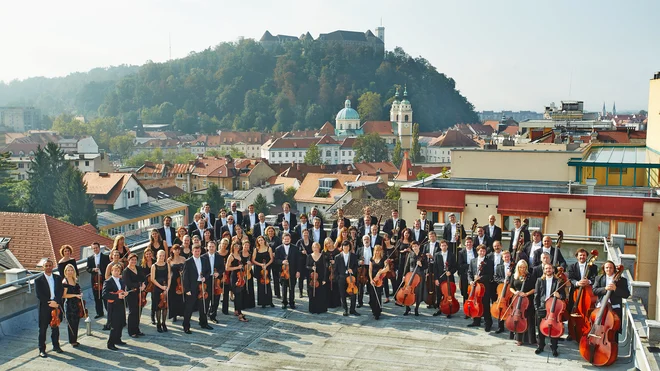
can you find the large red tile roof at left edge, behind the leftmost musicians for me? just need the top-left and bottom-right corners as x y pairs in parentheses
(0, 212), (112, 270)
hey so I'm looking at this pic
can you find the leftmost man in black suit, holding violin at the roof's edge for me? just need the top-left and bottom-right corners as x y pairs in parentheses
(34, 258), (64, 358)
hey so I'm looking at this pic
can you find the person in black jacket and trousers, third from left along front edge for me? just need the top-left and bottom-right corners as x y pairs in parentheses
(103, 264), (128, 350)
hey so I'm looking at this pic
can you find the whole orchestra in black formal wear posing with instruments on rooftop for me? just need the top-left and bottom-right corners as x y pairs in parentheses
(35, 203), (630, 363)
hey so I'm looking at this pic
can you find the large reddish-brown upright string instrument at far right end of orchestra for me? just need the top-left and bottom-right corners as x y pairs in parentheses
(580, 265), (623, 366)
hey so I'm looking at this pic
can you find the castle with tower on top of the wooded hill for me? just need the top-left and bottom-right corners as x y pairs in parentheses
(259, 26), (385, 54)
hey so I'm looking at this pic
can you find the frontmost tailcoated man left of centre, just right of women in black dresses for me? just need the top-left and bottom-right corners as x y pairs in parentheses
(183, 245), (213, 334)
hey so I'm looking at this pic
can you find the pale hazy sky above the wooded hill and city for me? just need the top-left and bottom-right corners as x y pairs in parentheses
(0, 0), (660, 111)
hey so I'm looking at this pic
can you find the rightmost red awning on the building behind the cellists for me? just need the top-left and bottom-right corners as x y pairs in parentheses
(587, 196), (644, 222)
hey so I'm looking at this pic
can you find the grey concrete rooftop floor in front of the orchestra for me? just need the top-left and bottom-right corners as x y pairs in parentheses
(0, 297), (634, 371)
